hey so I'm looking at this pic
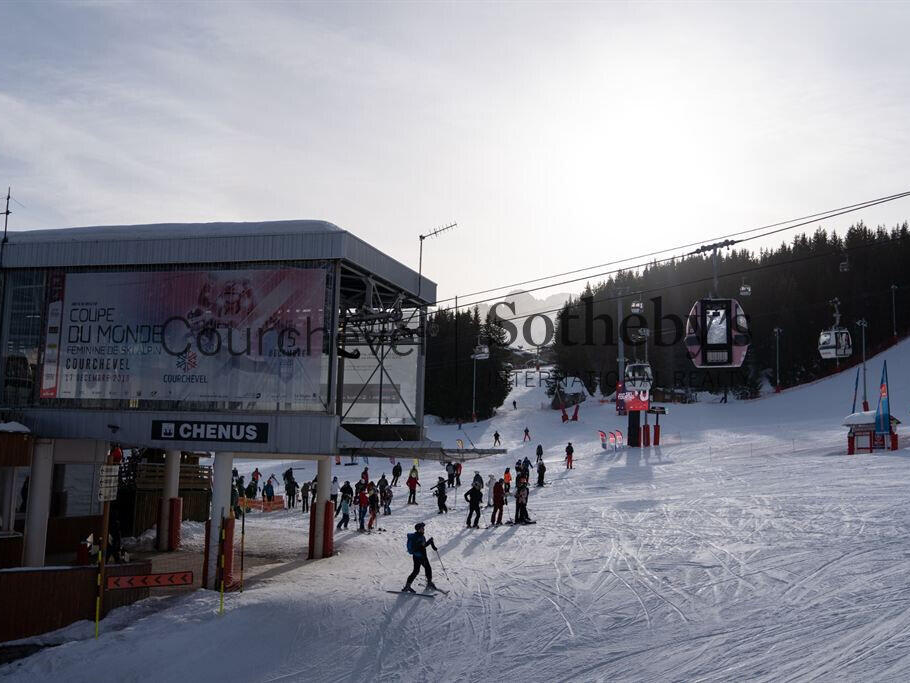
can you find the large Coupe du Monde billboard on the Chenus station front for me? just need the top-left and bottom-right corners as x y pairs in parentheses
(41, 268), (327, 408)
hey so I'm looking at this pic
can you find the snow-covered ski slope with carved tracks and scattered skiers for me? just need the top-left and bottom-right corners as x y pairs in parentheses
(0, 342), (910, 681)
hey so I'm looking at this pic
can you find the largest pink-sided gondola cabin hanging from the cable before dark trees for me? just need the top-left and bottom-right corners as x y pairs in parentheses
(685, 299), (750, 368)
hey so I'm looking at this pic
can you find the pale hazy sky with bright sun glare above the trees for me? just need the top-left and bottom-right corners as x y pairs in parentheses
(0, 2), (910, 312)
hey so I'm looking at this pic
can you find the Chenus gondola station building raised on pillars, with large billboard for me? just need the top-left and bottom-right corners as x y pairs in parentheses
(0, 220), (456, 636)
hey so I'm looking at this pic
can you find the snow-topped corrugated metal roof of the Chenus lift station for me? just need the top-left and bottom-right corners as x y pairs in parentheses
(3, 220), (436, 303)
